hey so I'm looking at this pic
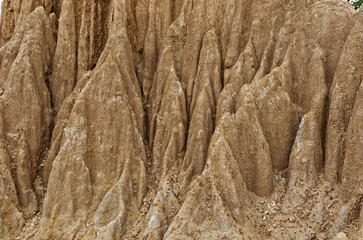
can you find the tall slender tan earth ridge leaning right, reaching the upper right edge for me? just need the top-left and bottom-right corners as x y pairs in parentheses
(325, 7), (363, 183)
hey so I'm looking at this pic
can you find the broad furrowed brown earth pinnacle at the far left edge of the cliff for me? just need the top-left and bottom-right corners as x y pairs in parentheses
(0, 5), (54, 237)
